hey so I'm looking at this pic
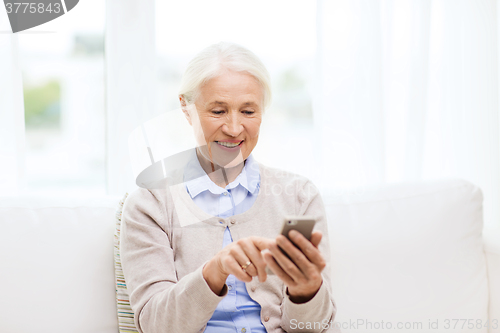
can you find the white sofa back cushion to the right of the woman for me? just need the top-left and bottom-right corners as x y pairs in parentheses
(323, 179), (488, 333)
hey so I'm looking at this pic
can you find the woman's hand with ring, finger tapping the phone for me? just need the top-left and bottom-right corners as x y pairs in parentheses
(203, 236), (276, 295)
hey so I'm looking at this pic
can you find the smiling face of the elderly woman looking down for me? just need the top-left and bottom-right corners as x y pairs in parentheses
(181, 70), (264, 168)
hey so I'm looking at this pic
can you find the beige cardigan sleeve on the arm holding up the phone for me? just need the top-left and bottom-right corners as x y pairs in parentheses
(281, 181), (336, 333)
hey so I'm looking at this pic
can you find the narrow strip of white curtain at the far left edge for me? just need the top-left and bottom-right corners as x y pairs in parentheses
(0, 10), (25, 196)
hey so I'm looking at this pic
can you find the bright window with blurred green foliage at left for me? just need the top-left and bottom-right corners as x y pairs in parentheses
(17, 0), (106, 195)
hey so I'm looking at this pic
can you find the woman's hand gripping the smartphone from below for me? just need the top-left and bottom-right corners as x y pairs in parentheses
(263, 230), (326, 303)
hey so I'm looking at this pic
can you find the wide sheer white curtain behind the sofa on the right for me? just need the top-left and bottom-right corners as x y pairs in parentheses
(314, 0), (500, 227)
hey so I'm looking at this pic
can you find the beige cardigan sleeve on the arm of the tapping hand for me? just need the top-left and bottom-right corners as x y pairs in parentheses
(120, 188), (227, 333)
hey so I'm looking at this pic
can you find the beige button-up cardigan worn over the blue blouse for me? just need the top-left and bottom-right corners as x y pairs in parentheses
(120, 164), (337, 333)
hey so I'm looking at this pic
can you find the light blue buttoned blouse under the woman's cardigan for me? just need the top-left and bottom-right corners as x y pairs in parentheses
(184, 150), (267, 333)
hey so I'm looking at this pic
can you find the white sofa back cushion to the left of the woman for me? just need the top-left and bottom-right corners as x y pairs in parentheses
(0, 196), (120, 333)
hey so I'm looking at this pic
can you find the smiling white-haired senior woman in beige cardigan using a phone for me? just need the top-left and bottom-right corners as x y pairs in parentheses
(121, 43), (336, 333)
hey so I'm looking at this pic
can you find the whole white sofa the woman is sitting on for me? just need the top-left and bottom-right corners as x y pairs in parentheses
(0, 179), (500, 333)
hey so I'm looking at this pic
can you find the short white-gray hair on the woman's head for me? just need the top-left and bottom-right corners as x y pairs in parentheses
(179, 42), (271, 108)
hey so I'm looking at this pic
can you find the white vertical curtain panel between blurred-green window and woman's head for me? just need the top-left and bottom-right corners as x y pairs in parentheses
(106, 0), (156, 195)
